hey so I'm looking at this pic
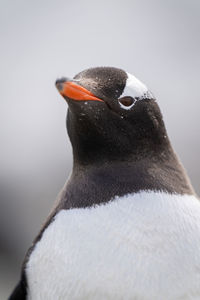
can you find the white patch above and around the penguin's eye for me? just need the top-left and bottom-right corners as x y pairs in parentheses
(119, 73), (154, 109)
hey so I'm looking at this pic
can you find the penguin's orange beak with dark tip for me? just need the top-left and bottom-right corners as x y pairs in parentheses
(55, 78), (104, 102)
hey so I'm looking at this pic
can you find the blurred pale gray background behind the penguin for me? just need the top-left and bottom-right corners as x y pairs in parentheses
(0, 0), (200, 299)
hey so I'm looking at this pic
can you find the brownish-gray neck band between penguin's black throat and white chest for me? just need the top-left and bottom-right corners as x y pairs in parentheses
(61, 141), (194, 209)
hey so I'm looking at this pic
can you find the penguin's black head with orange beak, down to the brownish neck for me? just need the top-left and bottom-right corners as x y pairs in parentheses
(56, 67), (170, 164)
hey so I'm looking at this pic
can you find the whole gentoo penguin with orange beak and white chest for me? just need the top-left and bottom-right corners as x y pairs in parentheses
(10, 67), (200, 300)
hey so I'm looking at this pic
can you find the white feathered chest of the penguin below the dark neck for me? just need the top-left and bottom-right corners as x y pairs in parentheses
(26, 192), (200, 300)
